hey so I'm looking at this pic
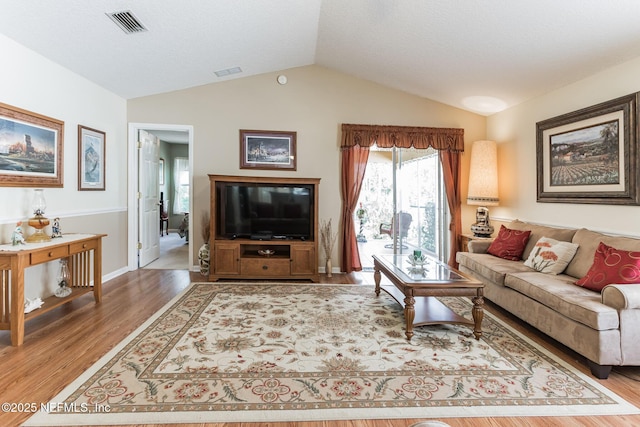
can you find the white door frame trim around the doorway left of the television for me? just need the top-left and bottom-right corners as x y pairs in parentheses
(127, 123), (194, 271)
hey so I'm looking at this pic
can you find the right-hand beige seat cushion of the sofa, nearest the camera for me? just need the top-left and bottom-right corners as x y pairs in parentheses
(504, 272), (619, 331)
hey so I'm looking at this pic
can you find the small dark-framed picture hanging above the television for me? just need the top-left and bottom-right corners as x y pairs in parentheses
(240, 129), (296, 171)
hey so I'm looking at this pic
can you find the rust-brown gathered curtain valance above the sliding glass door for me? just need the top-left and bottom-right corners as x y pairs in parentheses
(340, 123), (464, 152)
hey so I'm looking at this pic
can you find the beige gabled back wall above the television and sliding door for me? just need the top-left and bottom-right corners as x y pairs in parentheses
(128, 66), (485, 266)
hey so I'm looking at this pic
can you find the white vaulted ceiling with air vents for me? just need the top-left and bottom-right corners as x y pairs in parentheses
(0, 0), (640, 114)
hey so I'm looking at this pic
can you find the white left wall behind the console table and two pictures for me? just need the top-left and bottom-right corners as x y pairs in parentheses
(0, 35), (127, 298)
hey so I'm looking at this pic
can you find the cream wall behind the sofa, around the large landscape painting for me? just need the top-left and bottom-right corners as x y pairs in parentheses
(487, 59), (640, 236)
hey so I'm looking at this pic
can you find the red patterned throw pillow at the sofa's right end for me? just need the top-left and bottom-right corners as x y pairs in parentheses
(576, 242), (640, 292)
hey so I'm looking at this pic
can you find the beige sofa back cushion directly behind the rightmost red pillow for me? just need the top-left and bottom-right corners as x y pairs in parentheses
(565, 228), (640, 279)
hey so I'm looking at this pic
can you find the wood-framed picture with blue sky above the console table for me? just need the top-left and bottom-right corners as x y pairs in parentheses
(0, 103), (64, 187)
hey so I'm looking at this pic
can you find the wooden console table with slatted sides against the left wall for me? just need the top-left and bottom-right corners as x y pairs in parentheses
(0, 234), (106, 346)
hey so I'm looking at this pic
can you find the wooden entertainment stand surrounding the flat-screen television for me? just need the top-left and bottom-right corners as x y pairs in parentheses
(209, 175), (320, 282)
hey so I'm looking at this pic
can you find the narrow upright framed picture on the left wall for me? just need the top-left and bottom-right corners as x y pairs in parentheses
(78, 125), (106, 191)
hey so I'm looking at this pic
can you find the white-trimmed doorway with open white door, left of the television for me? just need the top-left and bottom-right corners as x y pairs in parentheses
(128, 123), (193, 270)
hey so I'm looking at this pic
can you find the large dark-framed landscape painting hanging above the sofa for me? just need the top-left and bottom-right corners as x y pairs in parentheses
(536, 92), (640, 205)
